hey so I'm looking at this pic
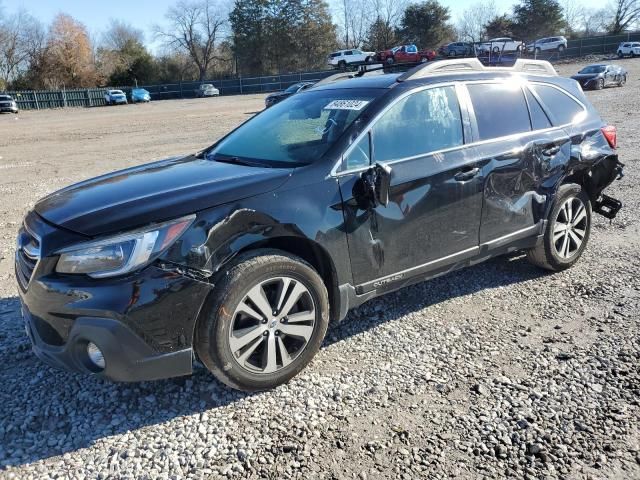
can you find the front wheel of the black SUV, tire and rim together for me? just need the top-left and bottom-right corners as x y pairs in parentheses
(195, 250), (329, 392)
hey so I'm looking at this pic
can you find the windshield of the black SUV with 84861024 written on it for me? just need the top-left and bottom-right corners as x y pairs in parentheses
(207, 89), (384, 167)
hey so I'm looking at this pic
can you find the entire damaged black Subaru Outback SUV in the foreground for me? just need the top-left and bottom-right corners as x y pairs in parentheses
(16, 59), (622, 390)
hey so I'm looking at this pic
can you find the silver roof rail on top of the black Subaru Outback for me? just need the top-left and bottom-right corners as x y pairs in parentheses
(398, 58), (558, 82)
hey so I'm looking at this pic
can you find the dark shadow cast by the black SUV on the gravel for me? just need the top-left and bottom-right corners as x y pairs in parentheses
(0, 255), (545, 470)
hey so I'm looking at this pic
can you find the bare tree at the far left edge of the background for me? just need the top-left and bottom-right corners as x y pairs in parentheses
(0, 10), (45, 85)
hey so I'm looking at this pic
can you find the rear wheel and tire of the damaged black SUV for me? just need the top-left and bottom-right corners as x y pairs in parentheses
(527, 183), (591, 272)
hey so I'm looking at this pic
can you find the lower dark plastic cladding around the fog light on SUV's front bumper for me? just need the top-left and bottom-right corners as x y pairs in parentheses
(22, 305), (193, 382)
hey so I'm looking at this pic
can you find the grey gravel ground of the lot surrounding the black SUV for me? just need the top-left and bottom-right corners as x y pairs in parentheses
(0, 60), (640, 479)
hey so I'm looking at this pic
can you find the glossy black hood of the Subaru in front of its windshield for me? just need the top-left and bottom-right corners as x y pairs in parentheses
(34, 155), (292, 236)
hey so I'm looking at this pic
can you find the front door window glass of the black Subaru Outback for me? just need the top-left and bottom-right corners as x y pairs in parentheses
(372, 87), (464, 162)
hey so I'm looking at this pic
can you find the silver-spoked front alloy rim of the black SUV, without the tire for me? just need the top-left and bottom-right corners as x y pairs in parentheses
(229, 276), (316, 374)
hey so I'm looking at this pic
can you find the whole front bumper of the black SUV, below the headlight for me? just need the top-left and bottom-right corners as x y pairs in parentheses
(16, 251), (211, 381)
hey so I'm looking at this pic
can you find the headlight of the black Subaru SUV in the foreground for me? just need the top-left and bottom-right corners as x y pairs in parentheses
(56, 215), (195, 278)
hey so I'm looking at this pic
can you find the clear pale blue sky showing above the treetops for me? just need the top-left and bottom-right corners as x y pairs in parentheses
(0, 0), (602, 49)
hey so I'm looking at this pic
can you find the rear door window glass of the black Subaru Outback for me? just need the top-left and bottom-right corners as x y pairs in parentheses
(467, 83), (531, 140)
